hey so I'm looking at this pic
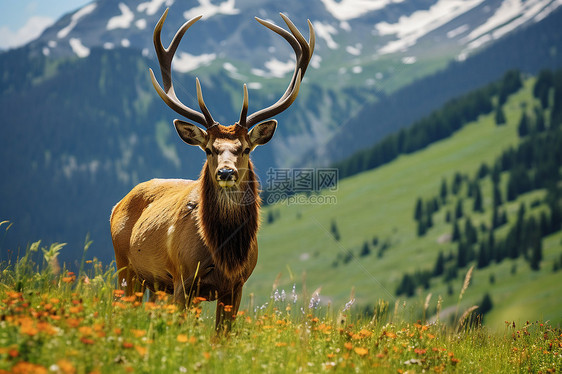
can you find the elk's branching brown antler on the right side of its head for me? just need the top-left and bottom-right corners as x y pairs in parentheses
(238, 13), (316, 129)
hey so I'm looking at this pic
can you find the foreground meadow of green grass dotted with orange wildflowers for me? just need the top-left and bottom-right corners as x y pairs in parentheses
(0, 248), (562, 374)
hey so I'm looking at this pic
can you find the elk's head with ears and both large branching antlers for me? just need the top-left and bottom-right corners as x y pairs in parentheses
(150, 9), (315, 188)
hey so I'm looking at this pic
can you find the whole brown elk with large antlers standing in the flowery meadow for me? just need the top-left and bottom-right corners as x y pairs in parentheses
(110, 9), (315, 331)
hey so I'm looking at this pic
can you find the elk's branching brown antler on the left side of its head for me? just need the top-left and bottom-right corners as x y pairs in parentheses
(149, 9), (216, 128)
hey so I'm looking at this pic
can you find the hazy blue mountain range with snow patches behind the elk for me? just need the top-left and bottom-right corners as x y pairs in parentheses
(0, 0), (562, 262)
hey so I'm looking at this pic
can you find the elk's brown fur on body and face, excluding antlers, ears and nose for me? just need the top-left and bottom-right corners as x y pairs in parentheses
(110, 126), (260, 328)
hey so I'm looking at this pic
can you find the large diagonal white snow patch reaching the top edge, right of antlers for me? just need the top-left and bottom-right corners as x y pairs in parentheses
(375, 0), (483, 54)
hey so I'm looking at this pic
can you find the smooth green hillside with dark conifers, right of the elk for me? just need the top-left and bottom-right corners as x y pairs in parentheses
(245, 75), (562, 328)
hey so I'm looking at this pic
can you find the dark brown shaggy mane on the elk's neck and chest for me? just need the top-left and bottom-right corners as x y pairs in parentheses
(198, 161), (261, 279)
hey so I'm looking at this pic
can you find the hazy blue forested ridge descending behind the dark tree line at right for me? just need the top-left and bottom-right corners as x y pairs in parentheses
(311, 4), (562, 164)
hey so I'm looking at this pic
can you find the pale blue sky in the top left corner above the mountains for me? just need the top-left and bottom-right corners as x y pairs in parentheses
(0, 0), (92, 49)
